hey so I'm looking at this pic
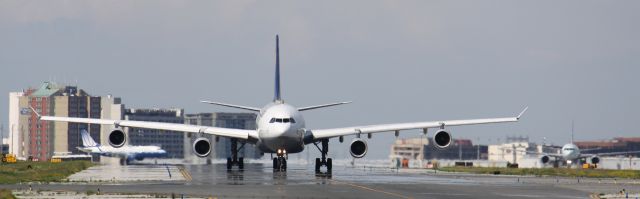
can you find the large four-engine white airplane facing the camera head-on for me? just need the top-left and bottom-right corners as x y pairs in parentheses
(32, 35), (527, 173)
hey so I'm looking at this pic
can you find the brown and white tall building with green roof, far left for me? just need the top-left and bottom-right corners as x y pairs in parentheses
(9, 82), (109, 161)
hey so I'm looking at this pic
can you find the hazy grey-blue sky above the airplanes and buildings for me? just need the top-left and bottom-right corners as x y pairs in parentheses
(0, 0), (640, 158)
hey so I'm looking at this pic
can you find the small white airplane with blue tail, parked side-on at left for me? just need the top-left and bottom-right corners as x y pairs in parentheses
(78, 129), (167, 165)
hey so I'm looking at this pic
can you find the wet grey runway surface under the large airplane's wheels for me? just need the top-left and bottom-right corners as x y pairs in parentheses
(0, 164), (640, 198)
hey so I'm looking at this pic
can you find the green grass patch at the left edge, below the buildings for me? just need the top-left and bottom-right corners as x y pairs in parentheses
(0, 161), (93, 184)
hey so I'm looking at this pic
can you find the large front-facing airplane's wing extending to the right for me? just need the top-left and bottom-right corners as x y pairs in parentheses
(311, 107), (528, 140)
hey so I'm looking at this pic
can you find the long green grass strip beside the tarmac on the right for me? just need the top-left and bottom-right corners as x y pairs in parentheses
(438, 167), (640, 179)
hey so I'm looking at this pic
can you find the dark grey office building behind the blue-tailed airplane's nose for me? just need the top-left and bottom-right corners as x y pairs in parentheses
(124, 109), (185, 158)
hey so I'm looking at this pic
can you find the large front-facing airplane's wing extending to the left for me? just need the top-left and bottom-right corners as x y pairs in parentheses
(31, 108), (258, 140)
